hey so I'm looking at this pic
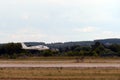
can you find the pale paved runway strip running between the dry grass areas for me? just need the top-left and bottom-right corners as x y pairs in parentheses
(0, 63), (120, 68)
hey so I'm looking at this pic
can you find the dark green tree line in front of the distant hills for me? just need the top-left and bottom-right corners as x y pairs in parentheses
(0, 42), (120, 59)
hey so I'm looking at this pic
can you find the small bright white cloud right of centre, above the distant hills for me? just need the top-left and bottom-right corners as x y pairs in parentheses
(74, 26), (97, 33)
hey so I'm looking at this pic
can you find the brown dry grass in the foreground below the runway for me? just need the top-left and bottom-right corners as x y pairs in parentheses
(0, 68), (120, 80)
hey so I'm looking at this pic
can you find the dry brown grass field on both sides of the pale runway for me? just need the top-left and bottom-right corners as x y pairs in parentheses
(0, 57), (120, 80)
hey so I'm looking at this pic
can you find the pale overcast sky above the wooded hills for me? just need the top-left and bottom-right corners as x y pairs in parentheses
(0, 0), (120, 43)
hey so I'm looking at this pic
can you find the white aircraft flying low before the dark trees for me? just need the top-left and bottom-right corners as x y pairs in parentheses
(21, 43), (49, 50)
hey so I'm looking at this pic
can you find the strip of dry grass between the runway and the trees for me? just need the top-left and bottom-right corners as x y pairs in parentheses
(0, 57), (120, 64)
